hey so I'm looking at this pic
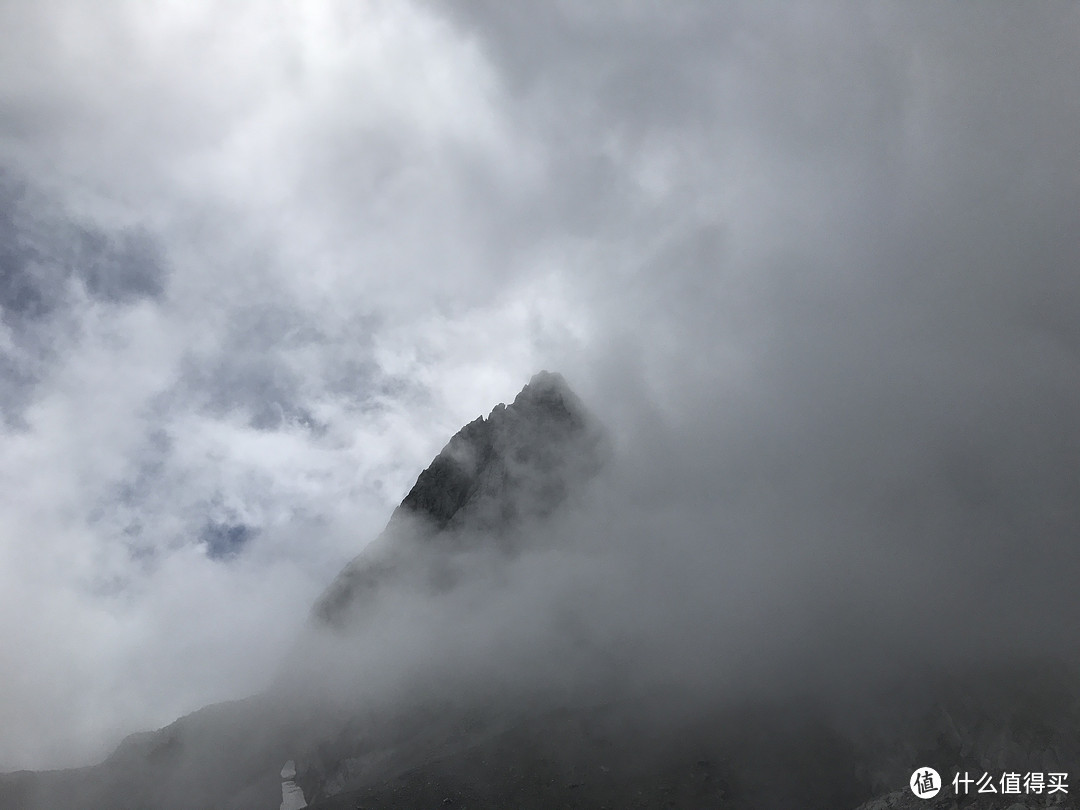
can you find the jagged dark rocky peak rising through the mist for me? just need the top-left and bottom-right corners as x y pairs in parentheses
(314, 372), (607, 624)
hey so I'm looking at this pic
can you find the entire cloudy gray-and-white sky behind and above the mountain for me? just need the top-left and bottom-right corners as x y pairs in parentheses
(0, 0), (1080, 770)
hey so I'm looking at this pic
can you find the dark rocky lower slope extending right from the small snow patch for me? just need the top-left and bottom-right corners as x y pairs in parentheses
(285, 661), (1080, 810)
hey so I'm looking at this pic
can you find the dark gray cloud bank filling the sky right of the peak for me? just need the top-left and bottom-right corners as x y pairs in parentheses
(406, 3), (1080, 699)
